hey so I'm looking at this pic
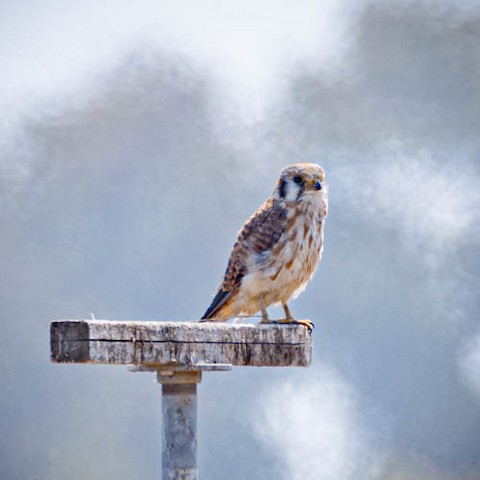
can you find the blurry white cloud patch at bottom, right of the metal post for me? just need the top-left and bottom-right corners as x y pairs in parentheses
(255, 366), (378, 480)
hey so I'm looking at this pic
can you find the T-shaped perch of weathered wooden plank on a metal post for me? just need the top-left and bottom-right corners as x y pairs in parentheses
(50, 320), (312, 480)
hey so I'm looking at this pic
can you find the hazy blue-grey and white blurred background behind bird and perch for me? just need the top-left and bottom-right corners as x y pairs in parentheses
(0, 0), (480, 480)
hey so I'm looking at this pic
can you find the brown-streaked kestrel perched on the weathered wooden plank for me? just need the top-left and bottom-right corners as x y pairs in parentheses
(201, 163), (328, 330)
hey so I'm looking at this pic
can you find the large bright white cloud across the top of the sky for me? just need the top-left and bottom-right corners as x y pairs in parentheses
(0, 0), (356, 135)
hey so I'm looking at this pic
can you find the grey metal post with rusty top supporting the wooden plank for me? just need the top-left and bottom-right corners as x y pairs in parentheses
(157, 372), (201, 480)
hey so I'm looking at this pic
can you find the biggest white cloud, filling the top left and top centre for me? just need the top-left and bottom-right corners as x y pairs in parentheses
(0, 0), (364, 202)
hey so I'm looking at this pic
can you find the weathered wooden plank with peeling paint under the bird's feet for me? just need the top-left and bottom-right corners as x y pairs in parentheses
(51, 320), (312, 370)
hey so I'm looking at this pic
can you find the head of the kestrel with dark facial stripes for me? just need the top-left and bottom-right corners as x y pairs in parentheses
(273, 163), (326, 202)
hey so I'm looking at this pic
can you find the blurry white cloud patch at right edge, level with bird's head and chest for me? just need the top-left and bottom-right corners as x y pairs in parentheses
(337, 146), (480, 265)
